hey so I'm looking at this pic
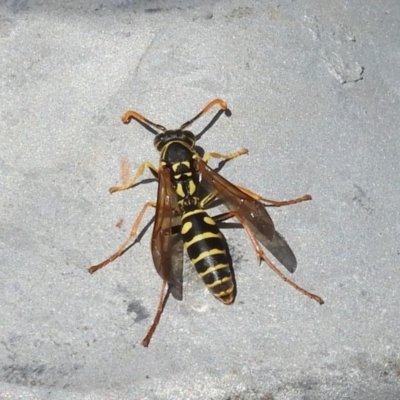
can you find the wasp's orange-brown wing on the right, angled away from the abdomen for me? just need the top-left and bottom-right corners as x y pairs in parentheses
(196, 158), (297, 272)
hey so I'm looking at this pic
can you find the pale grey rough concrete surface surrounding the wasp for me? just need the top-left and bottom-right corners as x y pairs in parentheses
(0, 0), (400, 400)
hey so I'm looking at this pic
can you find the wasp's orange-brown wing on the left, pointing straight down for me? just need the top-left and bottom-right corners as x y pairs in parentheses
(151, 167), (183, 300)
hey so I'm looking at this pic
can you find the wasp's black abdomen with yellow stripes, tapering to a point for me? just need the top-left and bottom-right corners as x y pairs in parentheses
(181, 209), (235, 304)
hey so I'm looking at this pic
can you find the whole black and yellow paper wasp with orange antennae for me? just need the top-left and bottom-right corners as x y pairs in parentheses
(89, 99), (323, 347)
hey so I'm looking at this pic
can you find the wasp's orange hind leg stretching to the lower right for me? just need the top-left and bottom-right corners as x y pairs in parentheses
(211, 211), (324, 304)
